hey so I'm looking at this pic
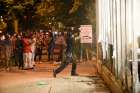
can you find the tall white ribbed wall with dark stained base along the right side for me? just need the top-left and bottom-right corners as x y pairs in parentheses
(96, 0), (140, 93)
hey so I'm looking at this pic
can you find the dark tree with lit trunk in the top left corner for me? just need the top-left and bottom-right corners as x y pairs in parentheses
(0, 0), (37, 32)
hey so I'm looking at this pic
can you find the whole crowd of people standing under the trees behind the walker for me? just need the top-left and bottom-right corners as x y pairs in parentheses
(0, 31), (77, 76)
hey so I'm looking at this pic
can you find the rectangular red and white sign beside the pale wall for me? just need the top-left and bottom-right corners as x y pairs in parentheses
(80, 25), (92, 43)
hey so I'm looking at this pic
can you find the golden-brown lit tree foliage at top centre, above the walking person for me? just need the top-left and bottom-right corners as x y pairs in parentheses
(33, 0), (81, 29)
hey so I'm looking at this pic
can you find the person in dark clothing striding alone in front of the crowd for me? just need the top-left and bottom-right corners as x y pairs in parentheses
(53, 32), (78, 77)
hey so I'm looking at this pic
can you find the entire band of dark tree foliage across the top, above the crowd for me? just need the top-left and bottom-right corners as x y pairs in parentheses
(0, 0), (95, 31)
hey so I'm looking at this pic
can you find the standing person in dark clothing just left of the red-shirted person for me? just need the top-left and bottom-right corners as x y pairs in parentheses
(16, 36), (24, 69)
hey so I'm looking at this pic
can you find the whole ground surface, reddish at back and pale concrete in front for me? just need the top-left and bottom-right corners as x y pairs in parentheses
(0, 62), (110, 93)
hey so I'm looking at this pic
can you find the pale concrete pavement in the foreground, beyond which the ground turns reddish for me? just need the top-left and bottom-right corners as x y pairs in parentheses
(0, 76), (110, 93)
